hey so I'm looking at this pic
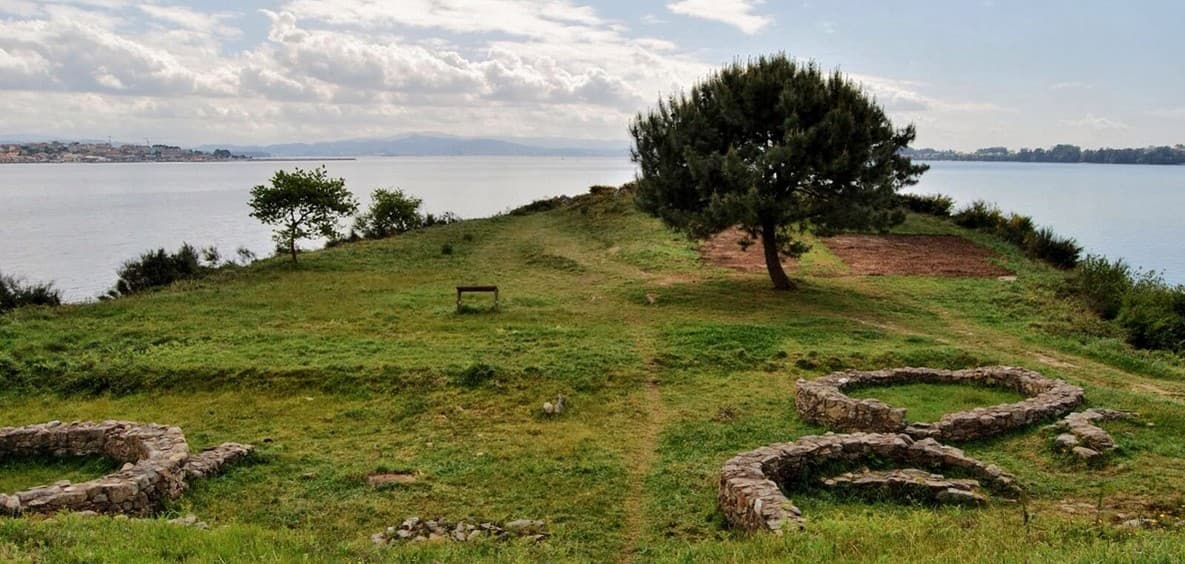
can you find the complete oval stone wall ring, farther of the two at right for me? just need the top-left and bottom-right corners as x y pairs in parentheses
(794, 366), (1083, 441)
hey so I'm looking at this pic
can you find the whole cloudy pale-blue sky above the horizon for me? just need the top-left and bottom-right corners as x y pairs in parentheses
(0, 0), (1185, 150)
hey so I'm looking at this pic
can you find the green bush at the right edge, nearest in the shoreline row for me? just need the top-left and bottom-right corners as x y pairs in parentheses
(1115, 273), (1185, 352)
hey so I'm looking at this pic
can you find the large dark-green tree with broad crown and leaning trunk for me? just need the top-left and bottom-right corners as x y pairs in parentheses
(629, 55), (927, 289)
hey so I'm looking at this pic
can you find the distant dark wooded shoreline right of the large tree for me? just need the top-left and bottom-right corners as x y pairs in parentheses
(902, 145), (1185, 165)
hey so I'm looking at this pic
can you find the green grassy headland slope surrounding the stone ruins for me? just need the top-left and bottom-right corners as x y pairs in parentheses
(0, 191), (1185, 562)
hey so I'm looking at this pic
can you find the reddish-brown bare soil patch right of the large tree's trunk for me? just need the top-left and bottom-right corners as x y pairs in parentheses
(822, 235), (1012, 277)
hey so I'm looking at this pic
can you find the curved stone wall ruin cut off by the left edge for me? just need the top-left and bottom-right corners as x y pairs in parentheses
(0, 421), (254, 515)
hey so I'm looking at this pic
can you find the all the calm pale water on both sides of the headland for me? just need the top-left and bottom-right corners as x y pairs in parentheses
(0, 156), (1185, 301)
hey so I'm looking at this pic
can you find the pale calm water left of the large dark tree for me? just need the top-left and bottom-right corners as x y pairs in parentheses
(0, 156), (634, 301)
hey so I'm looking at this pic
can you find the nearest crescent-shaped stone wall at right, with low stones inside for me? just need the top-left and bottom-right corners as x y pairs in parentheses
(717, 432), (1020, 532)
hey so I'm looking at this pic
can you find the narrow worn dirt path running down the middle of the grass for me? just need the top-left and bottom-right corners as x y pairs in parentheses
(617, 335), (667, 563)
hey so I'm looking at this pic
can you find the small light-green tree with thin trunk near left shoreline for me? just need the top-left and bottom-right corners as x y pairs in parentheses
(250, 166), (358, 263)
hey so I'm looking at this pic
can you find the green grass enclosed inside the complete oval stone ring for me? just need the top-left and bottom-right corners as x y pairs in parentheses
(846, 384), (1025, 423)
